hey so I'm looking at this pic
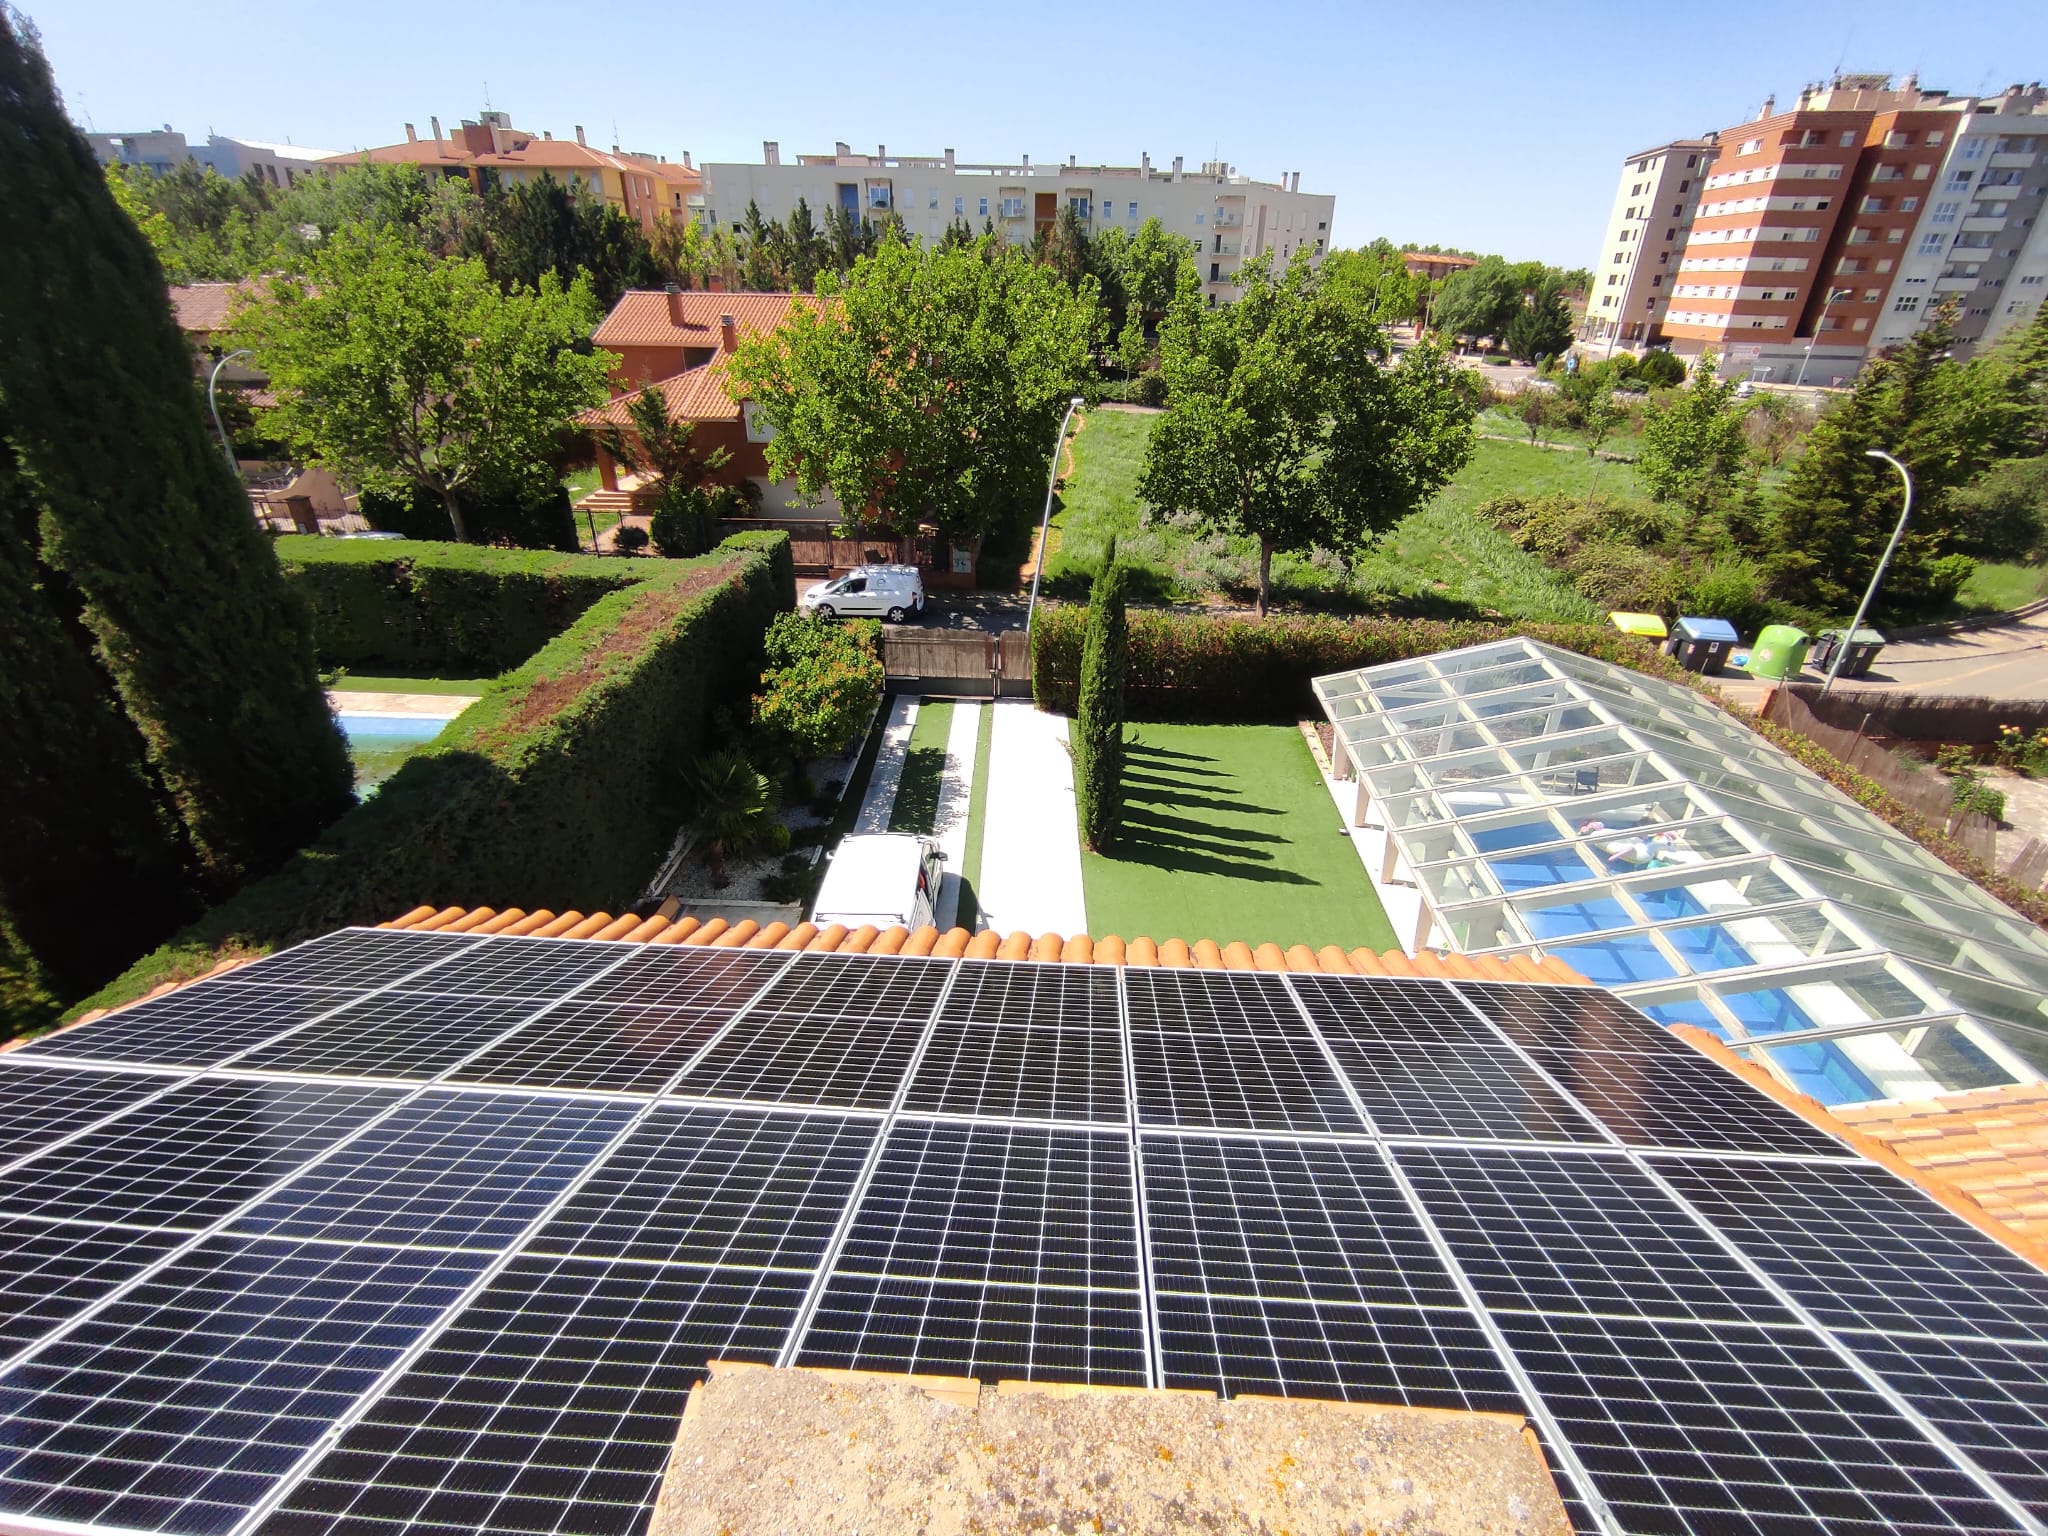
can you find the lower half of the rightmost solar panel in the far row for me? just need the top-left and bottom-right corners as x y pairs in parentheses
(1528, 1048), (1855, 1159)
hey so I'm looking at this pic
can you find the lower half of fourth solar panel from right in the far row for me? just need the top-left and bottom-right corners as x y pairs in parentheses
(903, 1016), (1130, 1122)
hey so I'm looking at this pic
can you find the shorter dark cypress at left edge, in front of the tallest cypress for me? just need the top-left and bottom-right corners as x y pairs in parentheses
(0, 444), (197, 999)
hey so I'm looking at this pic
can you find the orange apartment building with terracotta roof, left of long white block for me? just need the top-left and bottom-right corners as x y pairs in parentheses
(324, 113), (705, 229)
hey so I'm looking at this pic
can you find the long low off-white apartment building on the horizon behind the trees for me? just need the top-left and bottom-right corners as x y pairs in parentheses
(702, 141), (1337, 305)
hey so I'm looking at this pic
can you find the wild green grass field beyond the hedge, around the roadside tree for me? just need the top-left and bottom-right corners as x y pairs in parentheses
(1044, 410), (1605, 621)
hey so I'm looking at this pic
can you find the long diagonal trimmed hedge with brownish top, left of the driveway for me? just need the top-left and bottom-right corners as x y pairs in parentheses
(74, 535), (791, 1028)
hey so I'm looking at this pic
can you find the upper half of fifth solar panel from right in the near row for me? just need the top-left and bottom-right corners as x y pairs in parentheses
(528, 1104), (877, 1268)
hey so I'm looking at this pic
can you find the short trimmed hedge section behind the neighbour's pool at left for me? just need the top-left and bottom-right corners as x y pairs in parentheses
(276, 535), (638, 678)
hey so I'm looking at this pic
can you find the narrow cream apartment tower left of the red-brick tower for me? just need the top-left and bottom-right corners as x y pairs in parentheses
(1579, 133), (1716, 346)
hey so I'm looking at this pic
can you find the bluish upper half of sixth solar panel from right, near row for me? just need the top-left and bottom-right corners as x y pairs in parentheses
(233, 1094), (633, 1249)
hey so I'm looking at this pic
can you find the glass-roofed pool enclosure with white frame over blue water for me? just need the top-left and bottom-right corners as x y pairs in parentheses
(1315, 639), (2048, 1104)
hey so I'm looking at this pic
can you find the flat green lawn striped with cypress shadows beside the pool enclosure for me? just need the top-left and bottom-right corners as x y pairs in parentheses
(1081, 725), (1397, 950)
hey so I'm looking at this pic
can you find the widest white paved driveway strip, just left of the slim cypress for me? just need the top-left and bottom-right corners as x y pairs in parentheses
(979, 698), (1087, 934)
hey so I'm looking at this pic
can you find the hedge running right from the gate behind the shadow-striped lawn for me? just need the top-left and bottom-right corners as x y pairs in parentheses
(1032, 604), (1690, 723)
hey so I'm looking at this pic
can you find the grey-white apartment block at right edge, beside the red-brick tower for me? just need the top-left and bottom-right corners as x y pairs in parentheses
(1872, 84), (2048, 350)
